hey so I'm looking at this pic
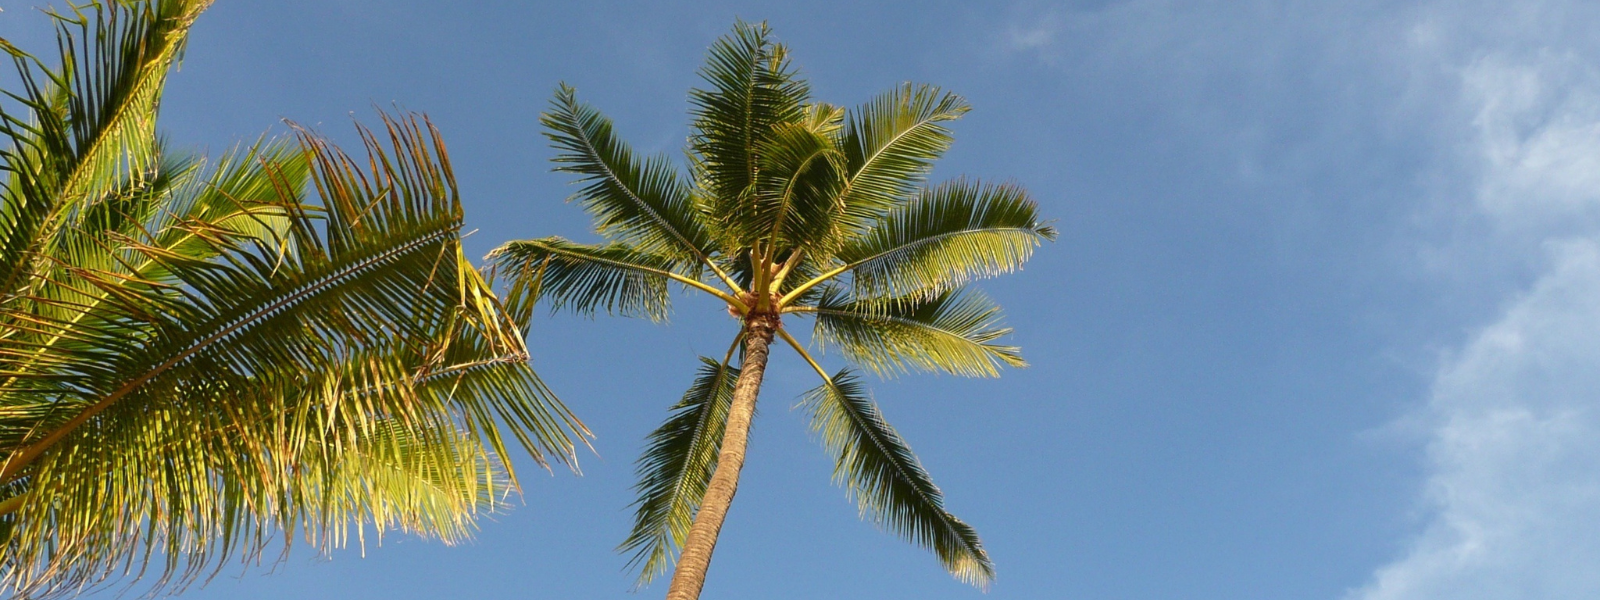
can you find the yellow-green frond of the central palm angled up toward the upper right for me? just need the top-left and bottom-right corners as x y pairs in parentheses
(840, 83), (971, 229)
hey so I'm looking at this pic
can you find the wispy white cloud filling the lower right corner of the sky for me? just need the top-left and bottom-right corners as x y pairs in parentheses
(1355, 240), (1600, 600)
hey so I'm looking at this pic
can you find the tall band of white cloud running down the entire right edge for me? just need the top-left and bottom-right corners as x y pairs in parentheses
(1350, 3), (1600, 600)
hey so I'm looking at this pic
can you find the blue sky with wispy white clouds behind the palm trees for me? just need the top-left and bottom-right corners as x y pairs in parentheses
(0, 0), (1600, 600)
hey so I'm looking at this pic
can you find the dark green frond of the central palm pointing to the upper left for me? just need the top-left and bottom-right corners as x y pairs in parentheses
(539, 85), (712, 264)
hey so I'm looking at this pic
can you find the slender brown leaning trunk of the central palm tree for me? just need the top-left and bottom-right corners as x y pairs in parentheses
(667, 314), (778, 600)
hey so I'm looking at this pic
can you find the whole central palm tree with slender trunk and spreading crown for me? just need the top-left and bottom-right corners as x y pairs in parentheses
(490, 22), (1056, 600)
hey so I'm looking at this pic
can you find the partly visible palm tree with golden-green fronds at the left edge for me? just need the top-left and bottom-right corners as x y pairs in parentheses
(0, 0), (587, 598)
